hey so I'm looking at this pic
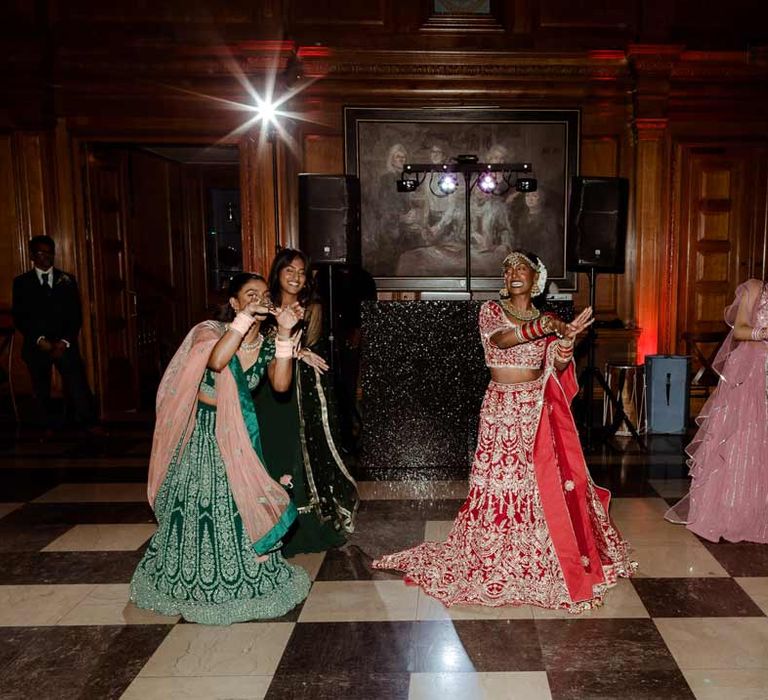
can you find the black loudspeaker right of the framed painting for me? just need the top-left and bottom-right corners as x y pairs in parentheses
(566, 177), (629, 272)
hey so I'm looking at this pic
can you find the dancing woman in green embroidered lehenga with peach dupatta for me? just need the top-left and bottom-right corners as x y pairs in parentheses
(131, 273), (310, 625)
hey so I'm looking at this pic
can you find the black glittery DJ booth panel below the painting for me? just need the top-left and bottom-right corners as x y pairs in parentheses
(360, 301), (490, 480)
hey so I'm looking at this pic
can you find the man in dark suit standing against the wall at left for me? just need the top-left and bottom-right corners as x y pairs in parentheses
(13, 236), (95, 429)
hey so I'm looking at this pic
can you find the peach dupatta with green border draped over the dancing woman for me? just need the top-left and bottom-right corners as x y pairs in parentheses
(147, 321), (296, 554)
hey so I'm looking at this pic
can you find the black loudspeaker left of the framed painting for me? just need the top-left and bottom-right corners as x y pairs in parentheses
(299, 173), (360, 264)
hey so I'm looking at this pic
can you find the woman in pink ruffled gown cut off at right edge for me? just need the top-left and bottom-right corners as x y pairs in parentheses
(666, 279), (768, 543)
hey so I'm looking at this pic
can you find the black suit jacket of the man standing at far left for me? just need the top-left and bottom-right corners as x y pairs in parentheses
(12, 268), (83, 358)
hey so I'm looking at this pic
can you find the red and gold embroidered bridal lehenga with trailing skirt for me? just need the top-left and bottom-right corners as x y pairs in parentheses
(373, 301), (637, 612)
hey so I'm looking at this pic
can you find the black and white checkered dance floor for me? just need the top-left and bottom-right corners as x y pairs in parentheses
(0, 432), (768, 700)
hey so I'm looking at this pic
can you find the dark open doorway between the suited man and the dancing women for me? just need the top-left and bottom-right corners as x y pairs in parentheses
(83, 143), (242, 421)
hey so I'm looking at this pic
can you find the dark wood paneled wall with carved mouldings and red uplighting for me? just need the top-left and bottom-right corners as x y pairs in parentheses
(0, 0), (768, 412)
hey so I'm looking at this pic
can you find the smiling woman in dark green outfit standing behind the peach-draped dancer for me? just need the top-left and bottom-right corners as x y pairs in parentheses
(254, 248), (358, 556)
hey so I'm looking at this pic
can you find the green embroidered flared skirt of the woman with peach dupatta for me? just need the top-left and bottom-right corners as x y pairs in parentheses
(131, 404), (310, 625)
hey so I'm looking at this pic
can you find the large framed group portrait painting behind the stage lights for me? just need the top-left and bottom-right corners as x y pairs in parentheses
(344, 107), (580, 292)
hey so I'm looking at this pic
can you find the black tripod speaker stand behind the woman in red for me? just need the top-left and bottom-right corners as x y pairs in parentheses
(579, 267), (646, 452)
